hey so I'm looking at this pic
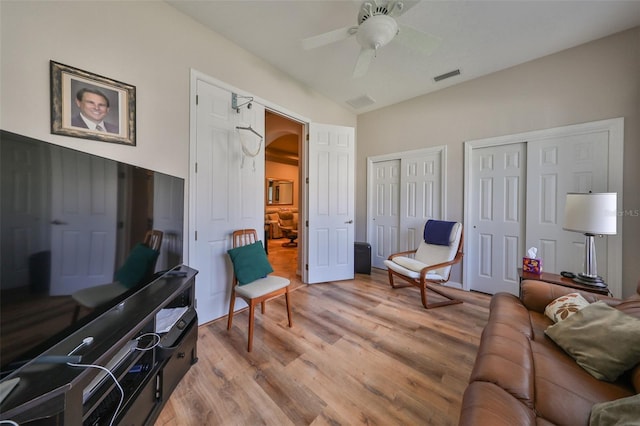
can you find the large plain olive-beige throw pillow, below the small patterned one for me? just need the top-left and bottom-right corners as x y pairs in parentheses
(545, 301), (640, 382)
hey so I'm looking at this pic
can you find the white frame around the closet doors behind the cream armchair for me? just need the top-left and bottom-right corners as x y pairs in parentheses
(365, 145), (448, 268)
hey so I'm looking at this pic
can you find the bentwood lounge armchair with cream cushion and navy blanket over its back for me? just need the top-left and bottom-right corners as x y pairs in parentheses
(384, 221), (463, 309)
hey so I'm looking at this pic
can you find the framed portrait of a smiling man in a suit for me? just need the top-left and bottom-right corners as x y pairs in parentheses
(50, 61), (136, 146)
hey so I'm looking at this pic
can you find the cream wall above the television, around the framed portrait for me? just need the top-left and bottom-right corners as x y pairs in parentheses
(0, 1), (356, 181)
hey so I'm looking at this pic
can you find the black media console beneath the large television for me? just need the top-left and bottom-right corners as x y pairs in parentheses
(0, 266), (198, 426)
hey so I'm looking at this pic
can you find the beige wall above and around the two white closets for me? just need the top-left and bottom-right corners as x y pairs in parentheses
(356, 28), (640, 296)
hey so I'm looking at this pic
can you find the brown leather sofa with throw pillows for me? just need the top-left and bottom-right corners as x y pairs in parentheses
(459, 281), (640, 426)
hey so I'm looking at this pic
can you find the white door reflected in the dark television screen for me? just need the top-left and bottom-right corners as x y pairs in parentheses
(50, 148), (118, 296)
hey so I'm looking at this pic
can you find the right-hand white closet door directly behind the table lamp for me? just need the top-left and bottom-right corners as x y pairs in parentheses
(526, 131), (609, 277)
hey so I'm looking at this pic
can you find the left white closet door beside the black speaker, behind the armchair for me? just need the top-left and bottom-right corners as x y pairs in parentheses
(371, 159), (400, 269)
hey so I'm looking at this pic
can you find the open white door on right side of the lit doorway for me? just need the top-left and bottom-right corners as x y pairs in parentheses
(305, 123), (355, 284)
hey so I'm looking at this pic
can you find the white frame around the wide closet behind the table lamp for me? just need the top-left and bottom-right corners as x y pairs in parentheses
(462, 117), (624, 297)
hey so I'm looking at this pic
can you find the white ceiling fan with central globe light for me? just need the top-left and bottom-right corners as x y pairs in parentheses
(302, 0), (440, 77)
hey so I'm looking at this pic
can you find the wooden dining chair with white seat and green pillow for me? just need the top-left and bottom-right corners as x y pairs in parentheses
(227, 229), (293, 352)
